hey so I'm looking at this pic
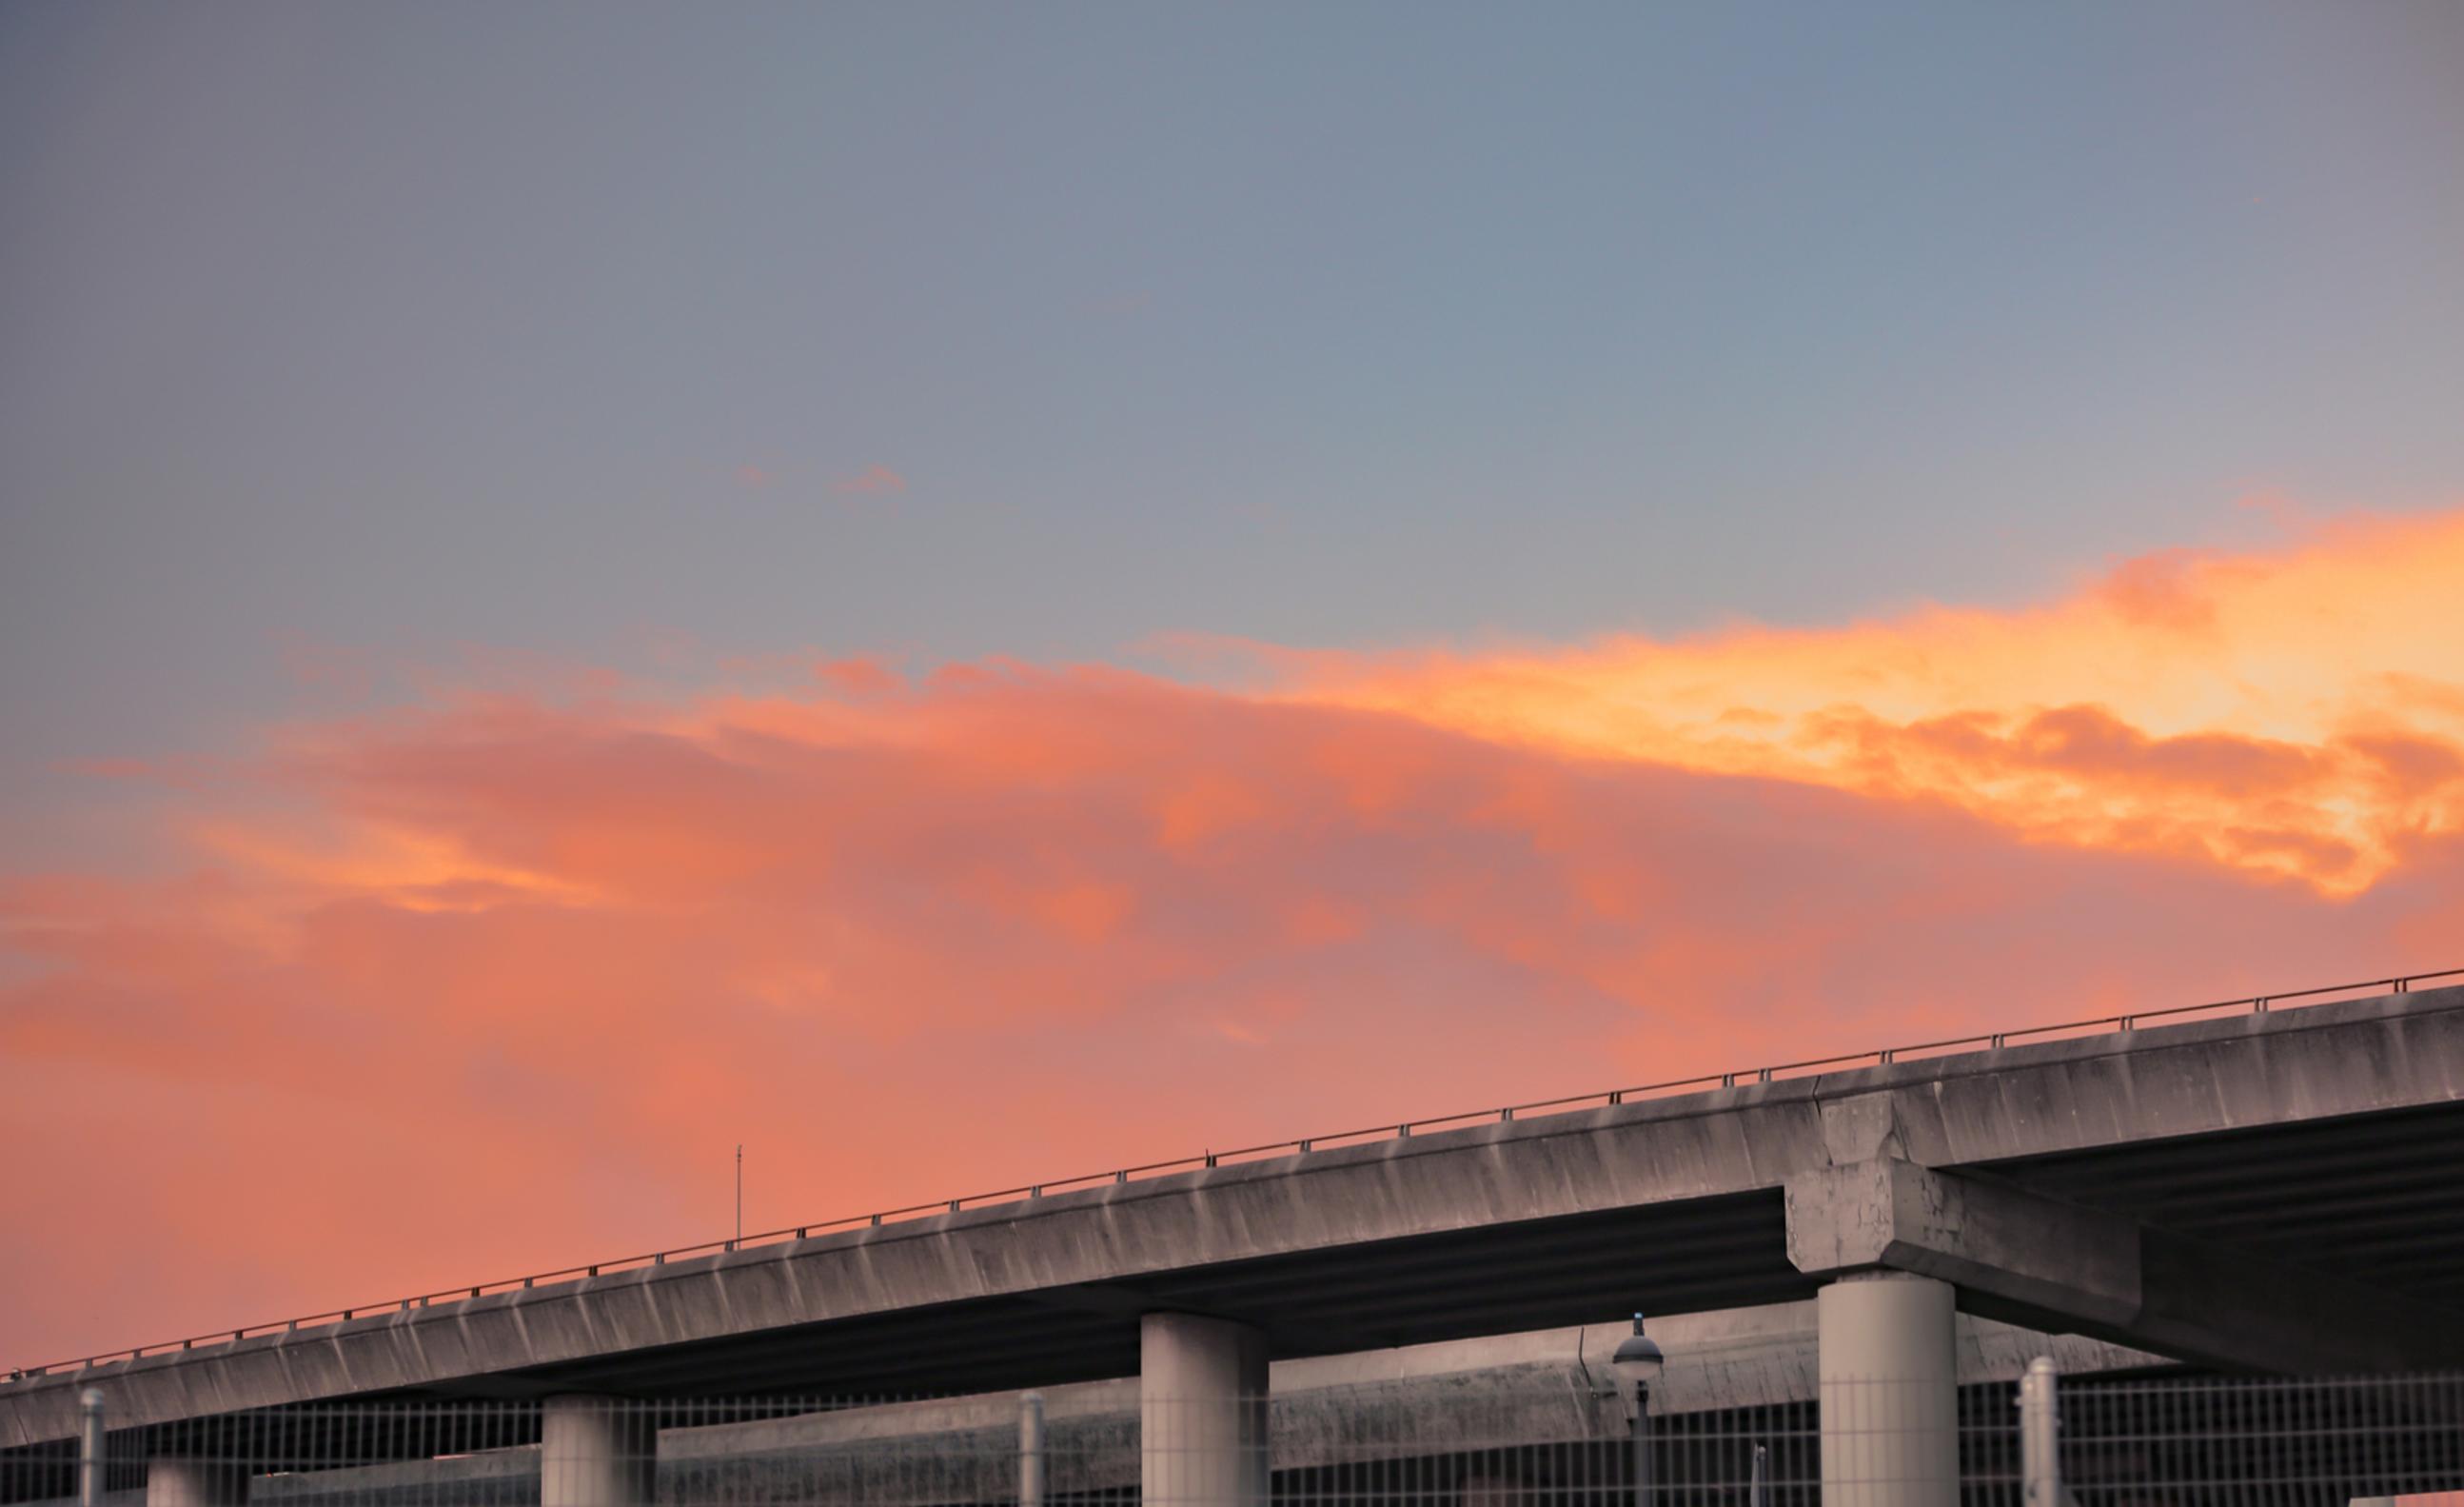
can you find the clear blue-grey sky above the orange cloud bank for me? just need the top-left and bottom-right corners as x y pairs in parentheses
(0, 3), (2464, 813)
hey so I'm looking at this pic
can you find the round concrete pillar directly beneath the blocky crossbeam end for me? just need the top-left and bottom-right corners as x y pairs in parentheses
(1814, 1273), (1959, 1507)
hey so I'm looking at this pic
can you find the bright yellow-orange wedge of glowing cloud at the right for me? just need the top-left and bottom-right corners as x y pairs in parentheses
(1267, 513), (2464, 895)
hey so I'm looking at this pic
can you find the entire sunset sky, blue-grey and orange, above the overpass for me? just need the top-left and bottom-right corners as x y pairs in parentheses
(0, 0), (2464, 1364)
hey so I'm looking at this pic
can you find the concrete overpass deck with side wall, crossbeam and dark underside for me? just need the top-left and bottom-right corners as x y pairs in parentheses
(0, 986), (2464, 1499)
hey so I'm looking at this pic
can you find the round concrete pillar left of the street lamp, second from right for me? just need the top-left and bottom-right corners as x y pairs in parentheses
(1138, 1315), (1269, 1507)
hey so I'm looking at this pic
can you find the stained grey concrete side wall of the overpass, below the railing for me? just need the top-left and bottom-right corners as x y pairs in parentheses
(0, 989), (2464, 1448)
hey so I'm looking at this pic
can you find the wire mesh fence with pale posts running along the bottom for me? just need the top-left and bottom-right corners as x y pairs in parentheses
(14, 1361), (2464, 1507)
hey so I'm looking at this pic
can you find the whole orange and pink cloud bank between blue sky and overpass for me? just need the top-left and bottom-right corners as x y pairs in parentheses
(0, 507), (2464, 1364)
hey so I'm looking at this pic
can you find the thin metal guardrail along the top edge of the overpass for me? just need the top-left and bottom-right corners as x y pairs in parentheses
(8, 967), (2464, 1381)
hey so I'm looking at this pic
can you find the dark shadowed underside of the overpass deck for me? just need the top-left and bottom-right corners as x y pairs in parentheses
(453, 1102), (2464, 1398)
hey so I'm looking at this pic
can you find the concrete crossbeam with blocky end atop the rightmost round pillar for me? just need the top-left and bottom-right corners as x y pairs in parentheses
(1786, 1157), (2464, 1374)
